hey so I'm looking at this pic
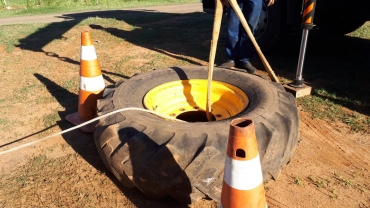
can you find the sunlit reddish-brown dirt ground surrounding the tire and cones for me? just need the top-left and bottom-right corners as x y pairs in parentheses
(0, 4), (370, 208)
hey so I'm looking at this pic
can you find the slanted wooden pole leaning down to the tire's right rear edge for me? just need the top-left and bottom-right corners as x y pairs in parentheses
(229, 0), (279, 83)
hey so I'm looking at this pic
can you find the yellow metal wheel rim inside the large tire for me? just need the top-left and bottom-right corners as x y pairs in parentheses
(144, 79), (249, 122)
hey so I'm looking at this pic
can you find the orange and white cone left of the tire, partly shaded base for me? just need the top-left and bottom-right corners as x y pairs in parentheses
(66, 31), (105, 133)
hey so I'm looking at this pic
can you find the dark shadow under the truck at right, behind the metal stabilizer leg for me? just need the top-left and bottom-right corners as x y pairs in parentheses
(261, 30), (370, 116)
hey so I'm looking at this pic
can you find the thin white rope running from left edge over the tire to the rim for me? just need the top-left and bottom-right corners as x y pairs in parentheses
(0, 108), (185, 155)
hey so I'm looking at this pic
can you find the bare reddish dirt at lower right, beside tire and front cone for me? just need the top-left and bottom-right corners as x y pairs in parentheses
(266, 112), (370, 207)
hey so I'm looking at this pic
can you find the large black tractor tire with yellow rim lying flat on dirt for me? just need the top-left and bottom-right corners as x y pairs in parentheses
(94, 66), (299, 204)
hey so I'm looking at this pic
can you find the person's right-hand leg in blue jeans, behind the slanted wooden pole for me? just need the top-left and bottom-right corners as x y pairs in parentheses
(239, 0), (262, 63)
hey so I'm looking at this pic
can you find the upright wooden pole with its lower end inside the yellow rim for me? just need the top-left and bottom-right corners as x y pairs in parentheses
(206, 0), (223, 121)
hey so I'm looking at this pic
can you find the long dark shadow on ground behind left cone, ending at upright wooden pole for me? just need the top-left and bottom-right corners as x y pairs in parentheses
(17, 10), (218, 65)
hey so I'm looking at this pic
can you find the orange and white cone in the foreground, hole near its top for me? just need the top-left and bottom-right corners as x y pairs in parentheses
(220, 118), (267, 208)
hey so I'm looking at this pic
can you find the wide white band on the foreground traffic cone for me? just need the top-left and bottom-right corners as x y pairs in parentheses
(224, 155), (263, 190)
